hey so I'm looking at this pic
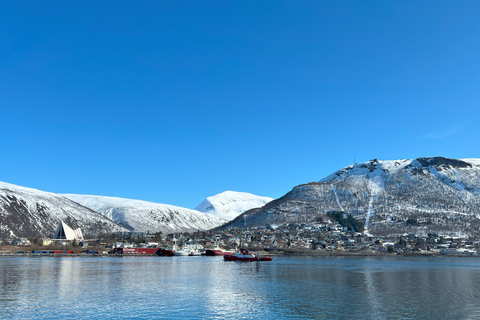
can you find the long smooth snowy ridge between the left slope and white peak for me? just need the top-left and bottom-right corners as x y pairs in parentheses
(63, 194), (227, 234)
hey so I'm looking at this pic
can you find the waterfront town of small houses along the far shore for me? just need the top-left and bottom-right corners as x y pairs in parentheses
(0, 223), (480, 256)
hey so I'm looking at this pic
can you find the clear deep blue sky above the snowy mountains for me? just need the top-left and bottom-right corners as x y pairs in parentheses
(0, 0), (480, 208)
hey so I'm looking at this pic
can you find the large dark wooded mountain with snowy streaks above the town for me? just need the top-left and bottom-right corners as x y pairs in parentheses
(222, 157), (480, 235)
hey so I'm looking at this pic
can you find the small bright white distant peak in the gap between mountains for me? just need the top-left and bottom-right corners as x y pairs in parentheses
(195, 191), (273, 220)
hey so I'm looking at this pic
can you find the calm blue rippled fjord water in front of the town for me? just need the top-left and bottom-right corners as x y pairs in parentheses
(0, 257), (480, 319)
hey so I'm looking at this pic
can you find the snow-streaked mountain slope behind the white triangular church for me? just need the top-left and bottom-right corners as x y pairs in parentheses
(0, 182), (126, 238)
